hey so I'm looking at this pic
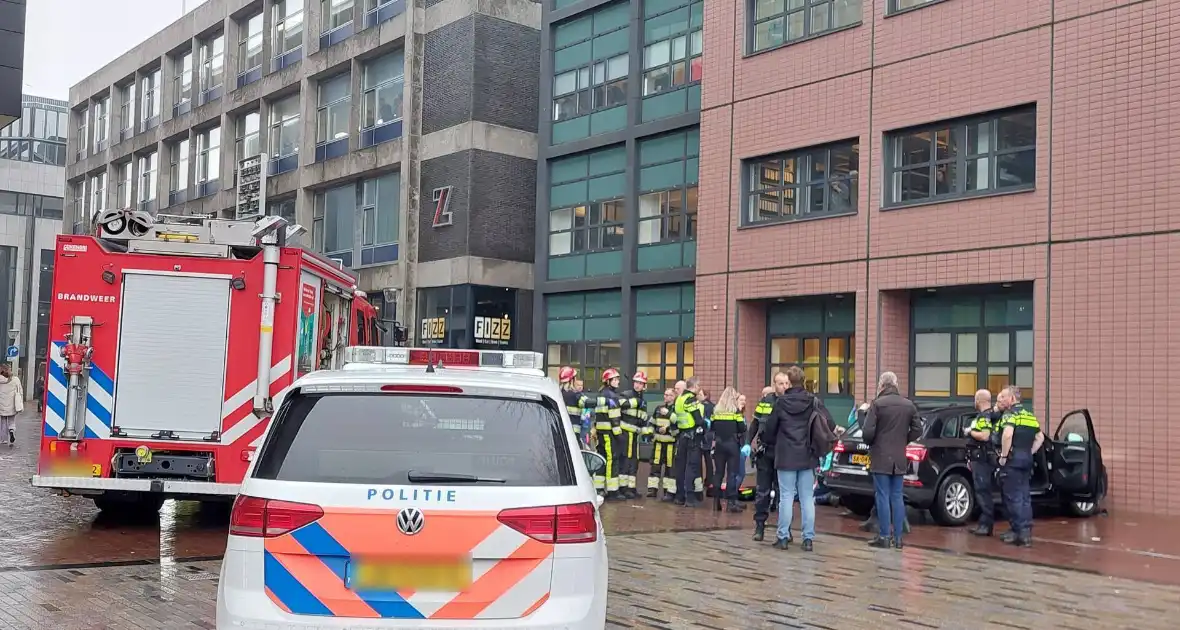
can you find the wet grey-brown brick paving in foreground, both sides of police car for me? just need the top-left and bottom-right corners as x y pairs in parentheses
(0, 531), (1180, 630)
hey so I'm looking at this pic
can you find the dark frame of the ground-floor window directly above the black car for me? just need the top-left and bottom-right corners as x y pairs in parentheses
(909, 294), (1036, 402)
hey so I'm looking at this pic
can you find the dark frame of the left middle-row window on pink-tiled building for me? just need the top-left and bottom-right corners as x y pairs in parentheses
(740, 139), (860, 228)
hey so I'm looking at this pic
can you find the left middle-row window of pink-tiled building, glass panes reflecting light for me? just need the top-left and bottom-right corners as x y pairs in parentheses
(743, 142), (860, 225)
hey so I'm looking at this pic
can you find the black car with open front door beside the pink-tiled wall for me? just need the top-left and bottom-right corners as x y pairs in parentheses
(827, 405), (1107, 525)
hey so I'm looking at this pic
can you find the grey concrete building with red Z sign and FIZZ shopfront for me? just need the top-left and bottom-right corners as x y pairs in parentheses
(67, 0), (540, 347)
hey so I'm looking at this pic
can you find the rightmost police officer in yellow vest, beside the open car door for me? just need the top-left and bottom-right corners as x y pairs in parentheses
(996, 386), (1044, 547)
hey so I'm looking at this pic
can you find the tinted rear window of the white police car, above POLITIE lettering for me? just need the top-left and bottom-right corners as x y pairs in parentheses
(254, 393), (575, 487)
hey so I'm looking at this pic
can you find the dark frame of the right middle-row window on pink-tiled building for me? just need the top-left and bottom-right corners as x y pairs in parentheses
(881, 103), (1037, 210)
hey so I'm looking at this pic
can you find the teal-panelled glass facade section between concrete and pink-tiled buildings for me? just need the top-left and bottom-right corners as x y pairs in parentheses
(533, 0), (703, 405)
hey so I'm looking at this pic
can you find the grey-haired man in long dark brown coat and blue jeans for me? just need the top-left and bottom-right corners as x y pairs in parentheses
(863, 372), (922, 549)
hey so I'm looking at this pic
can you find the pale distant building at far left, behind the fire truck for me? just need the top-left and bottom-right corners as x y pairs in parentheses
(0, 94), (70, 384)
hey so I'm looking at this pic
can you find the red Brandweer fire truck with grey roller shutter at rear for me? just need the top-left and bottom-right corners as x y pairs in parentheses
(33, 210), (378, 510)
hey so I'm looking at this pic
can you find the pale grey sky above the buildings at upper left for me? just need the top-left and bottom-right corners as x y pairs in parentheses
(24, 0), (205, 99)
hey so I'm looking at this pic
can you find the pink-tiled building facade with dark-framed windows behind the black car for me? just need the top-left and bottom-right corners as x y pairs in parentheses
(696, 0), (1180, 514)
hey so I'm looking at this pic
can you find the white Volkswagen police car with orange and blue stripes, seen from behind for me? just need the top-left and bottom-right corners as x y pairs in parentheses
(217, 347), (608, 630)
